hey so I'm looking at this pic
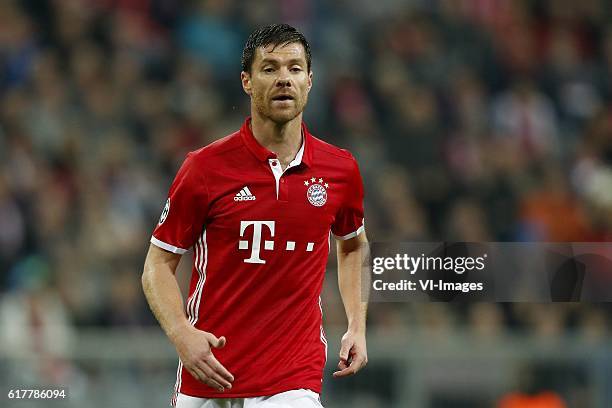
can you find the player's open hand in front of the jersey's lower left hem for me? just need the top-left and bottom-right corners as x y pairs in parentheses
(173, 326), (234, 392)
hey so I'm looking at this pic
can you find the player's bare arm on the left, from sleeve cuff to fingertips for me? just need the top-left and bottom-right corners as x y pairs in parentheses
(142, 244), (234, 391)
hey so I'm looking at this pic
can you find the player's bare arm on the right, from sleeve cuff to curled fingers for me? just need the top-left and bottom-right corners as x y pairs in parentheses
(334, 231), (368, 377)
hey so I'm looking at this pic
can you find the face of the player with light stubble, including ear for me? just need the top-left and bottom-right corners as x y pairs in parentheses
(241, 43), (312, 124)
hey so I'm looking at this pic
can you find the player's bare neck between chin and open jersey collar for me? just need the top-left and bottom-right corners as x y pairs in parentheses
(251, 111), (302, 165)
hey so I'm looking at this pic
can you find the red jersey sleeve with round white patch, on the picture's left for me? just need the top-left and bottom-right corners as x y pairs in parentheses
(151, 153), (209, 254)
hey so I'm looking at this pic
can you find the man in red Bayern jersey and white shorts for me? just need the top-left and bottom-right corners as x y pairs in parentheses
(142, 24), (367, 408)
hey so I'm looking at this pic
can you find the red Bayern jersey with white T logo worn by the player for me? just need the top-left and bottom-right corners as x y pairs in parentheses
(151, 119), (363, 398)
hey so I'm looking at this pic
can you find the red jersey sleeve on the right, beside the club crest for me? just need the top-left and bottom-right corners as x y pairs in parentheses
(331, 158), (364, 240)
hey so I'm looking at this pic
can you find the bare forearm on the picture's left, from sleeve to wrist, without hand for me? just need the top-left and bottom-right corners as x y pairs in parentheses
(142, 245), (189, 343)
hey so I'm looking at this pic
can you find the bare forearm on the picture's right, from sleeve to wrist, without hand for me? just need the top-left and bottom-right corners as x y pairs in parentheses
(338, 237), (368, 333)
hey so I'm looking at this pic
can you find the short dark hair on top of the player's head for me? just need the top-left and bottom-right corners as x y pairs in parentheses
(242, 24), (311, 72)
